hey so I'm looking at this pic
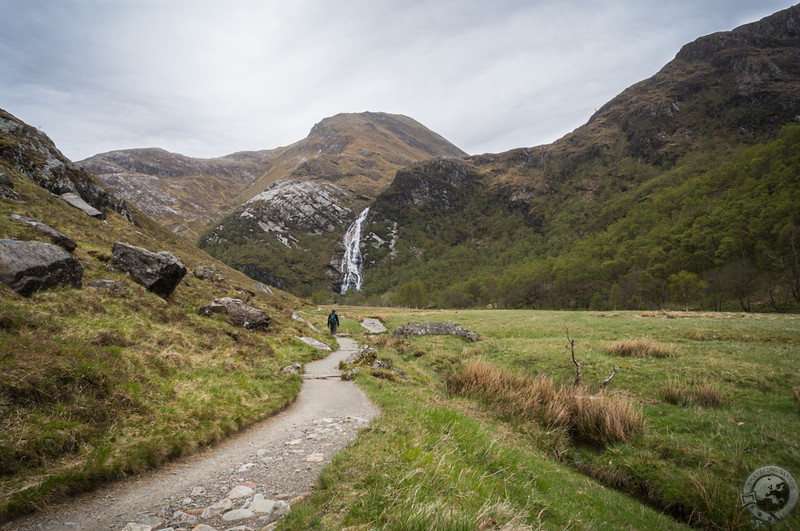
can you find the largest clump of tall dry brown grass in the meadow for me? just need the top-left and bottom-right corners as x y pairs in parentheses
(448, 360), (643, 445)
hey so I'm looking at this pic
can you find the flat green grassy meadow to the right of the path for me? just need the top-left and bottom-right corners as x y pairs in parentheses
(280, 307), (800, 530)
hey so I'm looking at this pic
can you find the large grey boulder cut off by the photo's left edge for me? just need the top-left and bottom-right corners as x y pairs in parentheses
(0, 239), (83, 297)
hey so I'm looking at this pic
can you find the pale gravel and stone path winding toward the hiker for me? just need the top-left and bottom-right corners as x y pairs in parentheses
(2, 337), (379, 531)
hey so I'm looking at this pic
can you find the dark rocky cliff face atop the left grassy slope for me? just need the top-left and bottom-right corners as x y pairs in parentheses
(0, 109), (133, 221)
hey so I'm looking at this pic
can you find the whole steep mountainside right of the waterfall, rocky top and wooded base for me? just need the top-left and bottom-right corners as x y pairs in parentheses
(364, 6), (800, 310)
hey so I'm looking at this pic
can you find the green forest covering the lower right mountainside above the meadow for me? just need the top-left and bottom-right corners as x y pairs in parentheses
(360, 125), (800, 312)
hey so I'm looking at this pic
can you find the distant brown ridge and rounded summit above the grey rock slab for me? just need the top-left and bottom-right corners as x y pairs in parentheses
(78, 112), (466, 245)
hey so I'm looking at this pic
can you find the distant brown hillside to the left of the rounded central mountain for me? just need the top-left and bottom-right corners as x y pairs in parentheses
(78, 148), (273, 241)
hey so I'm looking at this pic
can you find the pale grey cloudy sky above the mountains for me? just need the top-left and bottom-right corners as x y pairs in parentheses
(0, 0), (793, 161)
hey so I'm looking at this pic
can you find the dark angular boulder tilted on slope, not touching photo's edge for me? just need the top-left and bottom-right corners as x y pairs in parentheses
(111, 242), (186, 298)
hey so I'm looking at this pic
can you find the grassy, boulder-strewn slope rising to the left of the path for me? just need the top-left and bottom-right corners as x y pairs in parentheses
(0, 111), (326, 521)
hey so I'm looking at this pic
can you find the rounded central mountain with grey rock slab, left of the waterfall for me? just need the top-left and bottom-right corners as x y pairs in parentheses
(199, 112), (465, 296)
